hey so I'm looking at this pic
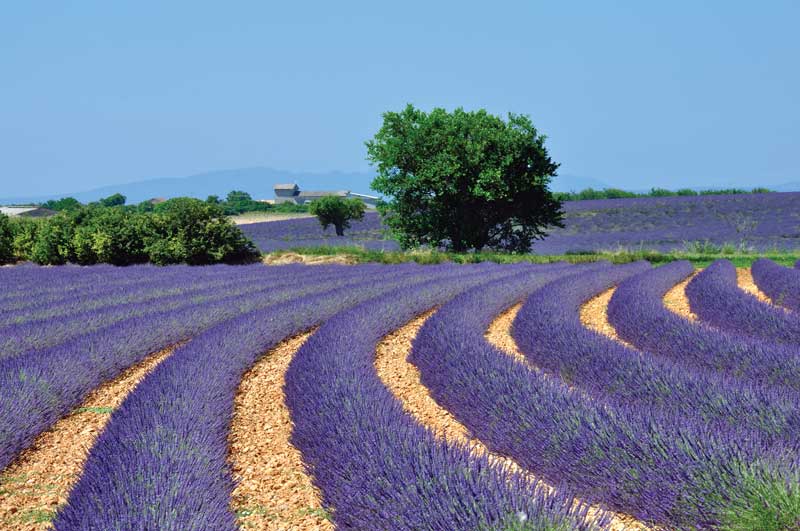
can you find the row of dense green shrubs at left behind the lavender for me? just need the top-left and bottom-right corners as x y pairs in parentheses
(0, 198), (260, 265)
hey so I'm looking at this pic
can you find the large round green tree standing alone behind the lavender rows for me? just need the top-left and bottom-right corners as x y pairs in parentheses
(367, 105), (563, 252)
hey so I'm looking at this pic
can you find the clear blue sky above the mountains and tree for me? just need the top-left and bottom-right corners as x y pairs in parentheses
(0, 0), (800, 196)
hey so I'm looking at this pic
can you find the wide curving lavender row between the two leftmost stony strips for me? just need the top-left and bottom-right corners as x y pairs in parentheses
(54, 266), (600, 530)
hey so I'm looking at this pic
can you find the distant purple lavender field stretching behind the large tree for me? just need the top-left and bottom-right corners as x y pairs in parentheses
(241, 192), (800, 254)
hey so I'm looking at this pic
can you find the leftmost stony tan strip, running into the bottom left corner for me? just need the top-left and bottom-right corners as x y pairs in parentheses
(0, 345), (177, 531)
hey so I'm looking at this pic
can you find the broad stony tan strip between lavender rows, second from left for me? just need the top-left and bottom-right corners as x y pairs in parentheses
(228, 333), (333, 531)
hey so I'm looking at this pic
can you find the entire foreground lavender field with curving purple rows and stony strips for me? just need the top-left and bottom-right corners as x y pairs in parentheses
(0, 260), (800, 531)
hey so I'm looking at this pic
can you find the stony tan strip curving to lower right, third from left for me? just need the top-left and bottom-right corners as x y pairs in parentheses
(375, 312), (649, 531)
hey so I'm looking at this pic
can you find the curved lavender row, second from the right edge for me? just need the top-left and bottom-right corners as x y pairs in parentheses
(686, 260), (800, 347)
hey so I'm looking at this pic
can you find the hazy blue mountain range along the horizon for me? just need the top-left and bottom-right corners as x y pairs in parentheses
(0, 167), (800, 205)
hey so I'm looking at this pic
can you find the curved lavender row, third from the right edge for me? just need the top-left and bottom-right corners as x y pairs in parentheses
(608, 261), (800, 392)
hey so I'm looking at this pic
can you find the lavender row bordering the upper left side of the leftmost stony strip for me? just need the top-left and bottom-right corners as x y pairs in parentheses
(0, 265), (417, 469)
